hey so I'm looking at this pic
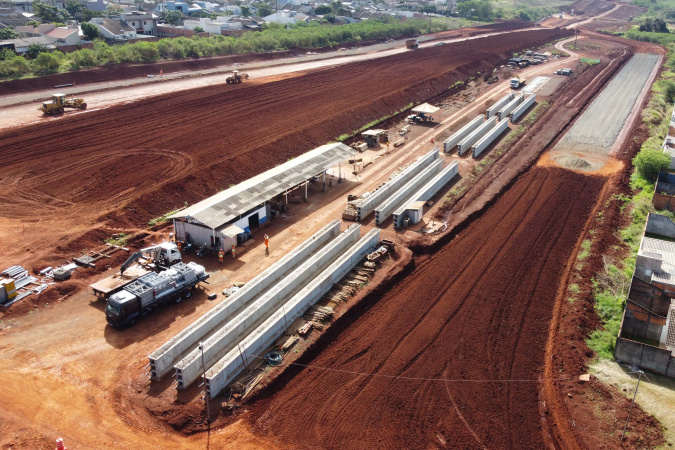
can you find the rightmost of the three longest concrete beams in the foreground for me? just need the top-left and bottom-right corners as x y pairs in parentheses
(206, 229), (380, 398)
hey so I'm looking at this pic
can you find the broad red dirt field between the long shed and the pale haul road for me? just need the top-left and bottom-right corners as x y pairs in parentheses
(0, 30), (569, 265)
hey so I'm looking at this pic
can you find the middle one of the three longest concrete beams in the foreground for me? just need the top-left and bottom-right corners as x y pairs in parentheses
(175, 224), (361, 389)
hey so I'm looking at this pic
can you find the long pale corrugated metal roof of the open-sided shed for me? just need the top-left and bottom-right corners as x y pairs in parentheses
(169, 143), (356, 229)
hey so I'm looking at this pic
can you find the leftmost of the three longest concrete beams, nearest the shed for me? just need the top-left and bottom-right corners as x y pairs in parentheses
(148, 220), (340, 380)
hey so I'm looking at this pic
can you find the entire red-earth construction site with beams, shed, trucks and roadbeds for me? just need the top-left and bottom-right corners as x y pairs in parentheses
(0, 0), (675, 449)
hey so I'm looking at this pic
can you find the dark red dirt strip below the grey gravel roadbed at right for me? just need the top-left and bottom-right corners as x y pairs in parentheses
(253, 167), (605, 448)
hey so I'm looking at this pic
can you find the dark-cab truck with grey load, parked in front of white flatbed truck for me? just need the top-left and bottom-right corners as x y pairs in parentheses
(105, 262), (209, 328)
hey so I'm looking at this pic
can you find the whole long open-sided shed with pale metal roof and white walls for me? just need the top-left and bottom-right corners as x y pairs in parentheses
(169, 143), (356, 251)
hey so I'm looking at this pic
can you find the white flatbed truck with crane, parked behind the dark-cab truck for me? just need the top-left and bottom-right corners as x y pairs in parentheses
(90, 242), (182, 300)
